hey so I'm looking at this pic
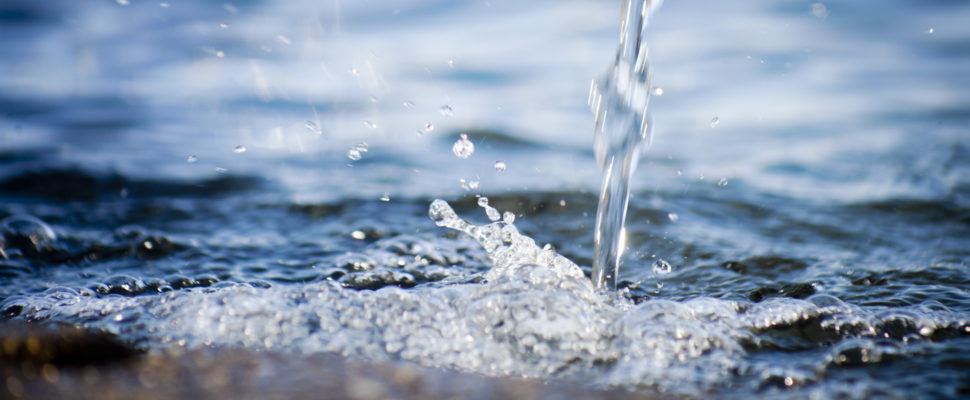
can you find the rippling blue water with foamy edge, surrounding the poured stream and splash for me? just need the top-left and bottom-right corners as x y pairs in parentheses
(0, 0), (970, 397)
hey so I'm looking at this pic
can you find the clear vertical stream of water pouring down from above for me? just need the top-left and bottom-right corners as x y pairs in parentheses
(589, 0), (661, 289)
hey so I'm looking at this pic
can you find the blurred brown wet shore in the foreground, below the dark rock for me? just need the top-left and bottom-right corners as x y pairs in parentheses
(0, 348), (648, 399)
